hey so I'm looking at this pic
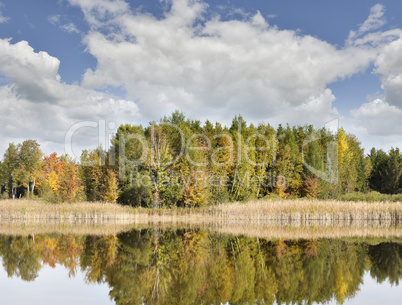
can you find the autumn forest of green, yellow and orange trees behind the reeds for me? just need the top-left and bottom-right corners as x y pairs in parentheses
(0, 111), (402, 207)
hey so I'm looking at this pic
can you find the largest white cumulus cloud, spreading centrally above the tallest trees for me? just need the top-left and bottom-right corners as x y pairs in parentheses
(66, 0), (391, 124)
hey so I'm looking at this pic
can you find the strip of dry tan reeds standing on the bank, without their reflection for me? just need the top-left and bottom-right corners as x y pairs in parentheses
(0, 200), (402, 222)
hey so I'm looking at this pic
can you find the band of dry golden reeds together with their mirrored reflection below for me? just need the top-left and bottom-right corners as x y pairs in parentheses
(0, 199), (402, 238)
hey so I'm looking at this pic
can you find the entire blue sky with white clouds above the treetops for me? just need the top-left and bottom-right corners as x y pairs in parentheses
(0, 0), (402, 156)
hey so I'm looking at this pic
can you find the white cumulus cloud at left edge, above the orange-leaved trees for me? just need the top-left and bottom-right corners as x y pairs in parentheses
(0, 39), (139, 152)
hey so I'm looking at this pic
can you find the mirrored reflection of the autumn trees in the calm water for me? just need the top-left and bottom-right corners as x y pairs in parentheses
(0, 229), (402, 304)
